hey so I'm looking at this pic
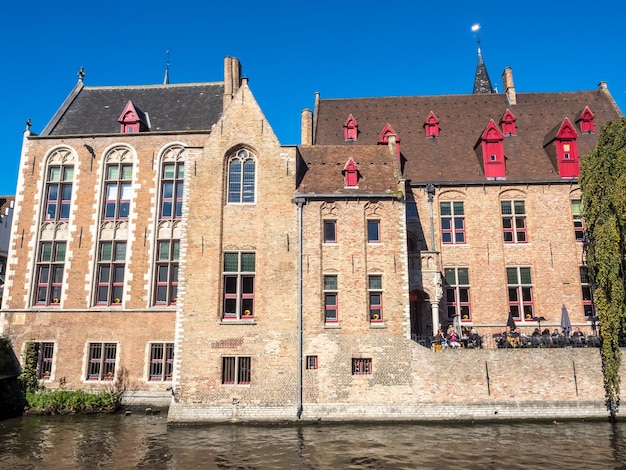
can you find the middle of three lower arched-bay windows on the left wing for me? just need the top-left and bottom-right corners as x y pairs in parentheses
(96, 241), (126, 305)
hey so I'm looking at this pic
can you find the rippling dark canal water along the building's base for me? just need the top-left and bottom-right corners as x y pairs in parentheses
(0, 411), (626, 470)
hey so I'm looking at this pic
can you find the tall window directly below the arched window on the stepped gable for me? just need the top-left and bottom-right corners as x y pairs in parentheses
(224, 252), (255, 320)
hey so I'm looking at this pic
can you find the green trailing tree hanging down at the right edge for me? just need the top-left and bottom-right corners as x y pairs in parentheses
(580, 118), (626, 422)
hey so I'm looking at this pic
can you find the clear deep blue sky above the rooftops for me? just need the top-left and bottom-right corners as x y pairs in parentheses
(0, 0), (626, 195)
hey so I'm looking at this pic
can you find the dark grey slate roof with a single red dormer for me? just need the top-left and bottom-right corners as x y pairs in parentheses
(40, 82), (224, 136)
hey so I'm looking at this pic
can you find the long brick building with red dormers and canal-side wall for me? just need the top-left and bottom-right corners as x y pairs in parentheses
(0, 54), (622, 422)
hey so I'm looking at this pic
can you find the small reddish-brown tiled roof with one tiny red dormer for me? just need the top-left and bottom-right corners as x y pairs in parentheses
(296, 143), (399, 196)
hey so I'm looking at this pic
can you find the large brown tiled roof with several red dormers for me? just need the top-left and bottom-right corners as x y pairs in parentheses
(314, 89), (621, 184)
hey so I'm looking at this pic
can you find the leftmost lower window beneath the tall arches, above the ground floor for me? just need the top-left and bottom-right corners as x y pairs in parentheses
(35, 241), (66, 305)
